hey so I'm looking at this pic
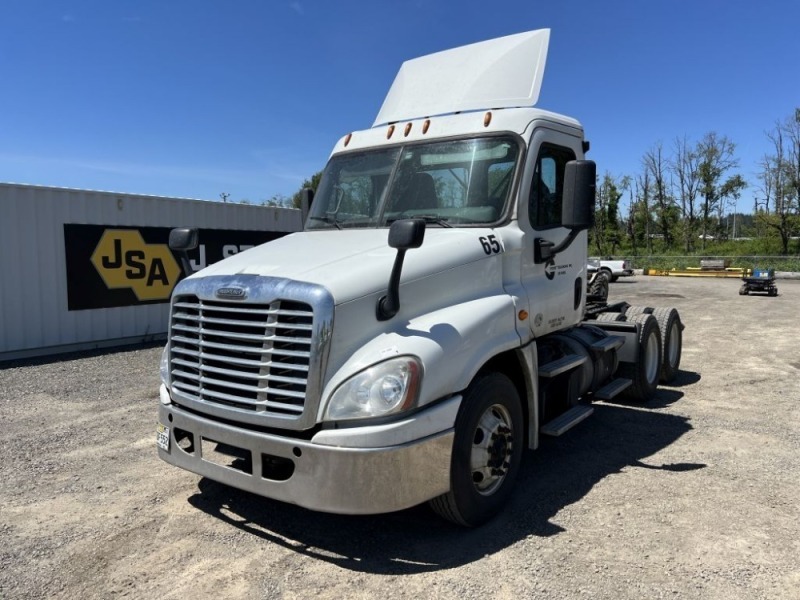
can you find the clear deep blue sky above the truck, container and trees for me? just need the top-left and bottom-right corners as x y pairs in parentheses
(0, 0), (800, 211)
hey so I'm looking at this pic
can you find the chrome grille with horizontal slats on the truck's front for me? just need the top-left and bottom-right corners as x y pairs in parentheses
(170, 295), (314, 418)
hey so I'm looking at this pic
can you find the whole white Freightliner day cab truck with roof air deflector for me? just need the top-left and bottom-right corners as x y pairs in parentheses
(157, 30), (683, 526)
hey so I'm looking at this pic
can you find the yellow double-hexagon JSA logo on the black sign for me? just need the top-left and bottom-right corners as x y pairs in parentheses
(90, 229), (181, 302)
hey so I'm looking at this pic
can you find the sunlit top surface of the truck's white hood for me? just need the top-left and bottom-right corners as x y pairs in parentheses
(192, 228), (502, 304)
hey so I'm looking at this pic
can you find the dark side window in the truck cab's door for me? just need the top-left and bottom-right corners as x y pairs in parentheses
(528, 144), (575, 229)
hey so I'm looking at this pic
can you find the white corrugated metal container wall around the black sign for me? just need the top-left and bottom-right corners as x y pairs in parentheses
(0, 183), (302, 360)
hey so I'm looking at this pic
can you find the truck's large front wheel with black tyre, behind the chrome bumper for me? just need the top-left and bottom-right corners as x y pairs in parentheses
(430, 373), (525, 527)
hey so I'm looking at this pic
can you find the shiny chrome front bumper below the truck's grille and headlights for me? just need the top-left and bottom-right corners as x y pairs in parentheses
(158, 390), (460, 514)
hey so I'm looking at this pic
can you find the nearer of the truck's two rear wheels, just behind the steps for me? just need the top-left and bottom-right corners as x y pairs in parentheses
(617, 314), (662, 402)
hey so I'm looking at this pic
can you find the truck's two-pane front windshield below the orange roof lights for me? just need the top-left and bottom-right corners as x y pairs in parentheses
(306, 136), (519, 229)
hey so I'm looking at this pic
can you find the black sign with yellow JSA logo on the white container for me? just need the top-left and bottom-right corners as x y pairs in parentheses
(64, 224), (285, 310)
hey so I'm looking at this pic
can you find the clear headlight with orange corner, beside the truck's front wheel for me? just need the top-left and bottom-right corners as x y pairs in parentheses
(325, 356), (422, 421)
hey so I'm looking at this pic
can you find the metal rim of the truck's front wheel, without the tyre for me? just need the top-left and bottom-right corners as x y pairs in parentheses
(470, 404), (514, 496)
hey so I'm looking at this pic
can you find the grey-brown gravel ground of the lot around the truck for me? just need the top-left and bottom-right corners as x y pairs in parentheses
(0, 276), (800, 600)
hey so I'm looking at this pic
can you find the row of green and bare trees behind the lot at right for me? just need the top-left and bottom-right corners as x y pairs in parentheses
(590, 109), (800, 256)
